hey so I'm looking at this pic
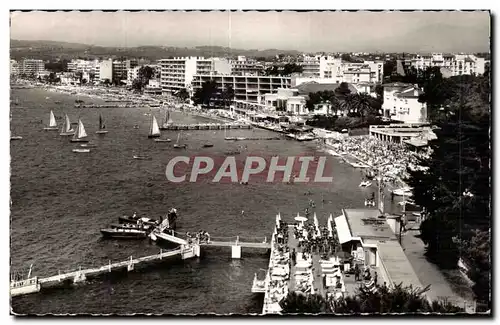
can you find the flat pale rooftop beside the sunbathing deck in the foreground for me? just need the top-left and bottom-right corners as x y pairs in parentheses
(343, 209), (396, 240)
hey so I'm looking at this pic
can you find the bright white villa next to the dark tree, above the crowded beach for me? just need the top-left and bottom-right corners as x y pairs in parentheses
(382, 82), (427, 123)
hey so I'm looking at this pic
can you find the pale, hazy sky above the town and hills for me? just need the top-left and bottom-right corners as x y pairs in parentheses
(11, 11), (490, 52)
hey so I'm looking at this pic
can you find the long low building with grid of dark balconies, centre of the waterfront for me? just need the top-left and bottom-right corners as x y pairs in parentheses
(192, 75), (291, 103)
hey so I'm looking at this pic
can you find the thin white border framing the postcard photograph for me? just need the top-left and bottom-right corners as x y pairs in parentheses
(0, 0), (500, 324)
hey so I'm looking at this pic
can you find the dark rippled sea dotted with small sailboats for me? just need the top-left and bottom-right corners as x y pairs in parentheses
(10, 88), (398, 315)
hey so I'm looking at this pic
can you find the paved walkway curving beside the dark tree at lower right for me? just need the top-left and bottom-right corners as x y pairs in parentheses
(401, 230), (474, 306)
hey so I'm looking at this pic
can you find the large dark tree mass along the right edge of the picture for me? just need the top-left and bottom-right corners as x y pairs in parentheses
(407, 76), (491, 267)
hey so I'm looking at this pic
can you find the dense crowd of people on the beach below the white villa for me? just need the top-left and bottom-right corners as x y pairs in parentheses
(326, 136), (431, 183)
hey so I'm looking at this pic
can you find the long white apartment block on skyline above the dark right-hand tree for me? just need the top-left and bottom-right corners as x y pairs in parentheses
(405, 53), (486, 76)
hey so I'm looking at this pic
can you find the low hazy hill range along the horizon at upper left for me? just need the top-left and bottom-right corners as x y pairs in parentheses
(10, 40), (300, 61)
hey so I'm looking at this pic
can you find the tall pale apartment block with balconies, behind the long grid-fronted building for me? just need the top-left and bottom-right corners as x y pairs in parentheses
(158, 57), (231, 94)
